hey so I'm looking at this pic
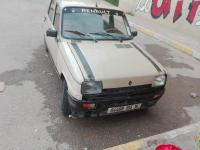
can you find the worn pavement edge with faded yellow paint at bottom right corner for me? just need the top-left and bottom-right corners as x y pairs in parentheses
(105, 122), (200, 150)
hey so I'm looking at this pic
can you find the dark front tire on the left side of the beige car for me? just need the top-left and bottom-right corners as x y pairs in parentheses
(62, 80), (71, 117)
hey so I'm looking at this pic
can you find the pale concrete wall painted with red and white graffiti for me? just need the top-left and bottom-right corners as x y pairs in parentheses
(119, 0), (200, 38)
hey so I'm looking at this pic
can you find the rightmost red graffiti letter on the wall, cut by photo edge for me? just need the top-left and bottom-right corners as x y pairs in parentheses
(187, 0), (200, 23)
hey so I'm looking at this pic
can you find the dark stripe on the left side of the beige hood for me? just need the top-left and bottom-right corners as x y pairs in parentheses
(71, 43), (95, 81)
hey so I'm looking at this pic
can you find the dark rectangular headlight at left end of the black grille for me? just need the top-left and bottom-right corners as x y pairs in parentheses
(81, 81), (103, 94)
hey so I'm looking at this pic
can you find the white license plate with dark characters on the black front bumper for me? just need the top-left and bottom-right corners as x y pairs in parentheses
(107, 104), (142, 114)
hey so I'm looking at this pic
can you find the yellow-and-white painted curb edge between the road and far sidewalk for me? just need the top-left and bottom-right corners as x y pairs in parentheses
(131, 22), (200, 60)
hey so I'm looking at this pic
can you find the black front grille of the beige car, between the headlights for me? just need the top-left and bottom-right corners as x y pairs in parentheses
(83, 84), (164, 102)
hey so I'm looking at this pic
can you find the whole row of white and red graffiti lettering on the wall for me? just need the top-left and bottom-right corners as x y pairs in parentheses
(136, 0), (200, 26)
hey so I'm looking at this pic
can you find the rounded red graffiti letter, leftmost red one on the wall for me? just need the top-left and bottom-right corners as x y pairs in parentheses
(151, 0), (171, 18)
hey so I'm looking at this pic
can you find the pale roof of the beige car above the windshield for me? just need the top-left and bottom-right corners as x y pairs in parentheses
(56, 0), (120, 11)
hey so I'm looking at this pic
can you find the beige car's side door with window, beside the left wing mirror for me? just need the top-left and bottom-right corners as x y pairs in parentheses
(45, 0), (60, 67)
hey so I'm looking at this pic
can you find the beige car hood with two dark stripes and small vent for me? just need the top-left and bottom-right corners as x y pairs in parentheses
(69, 41), (162, 88)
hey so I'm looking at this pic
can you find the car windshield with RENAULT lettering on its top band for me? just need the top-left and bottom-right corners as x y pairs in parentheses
(62, 7), (132, 40)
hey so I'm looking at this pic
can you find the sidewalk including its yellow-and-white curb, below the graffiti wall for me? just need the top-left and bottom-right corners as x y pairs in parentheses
(100, 1), (200, 60)
